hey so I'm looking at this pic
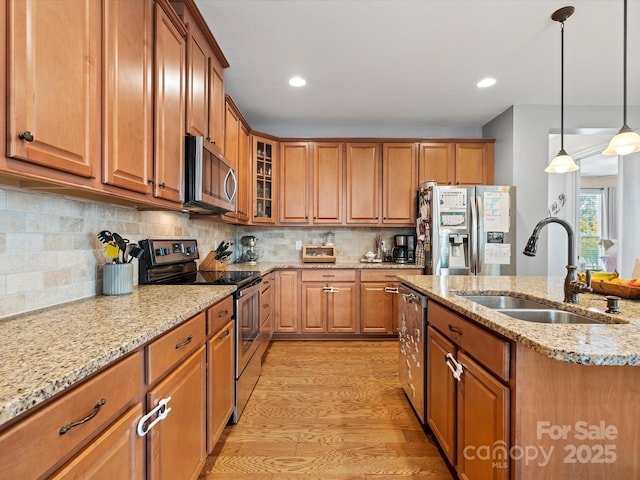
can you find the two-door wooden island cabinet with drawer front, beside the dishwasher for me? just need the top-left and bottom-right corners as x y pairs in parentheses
(427, 301), (510, 480)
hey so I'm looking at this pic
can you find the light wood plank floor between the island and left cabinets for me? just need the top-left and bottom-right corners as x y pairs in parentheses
(200, 341), (452, 480)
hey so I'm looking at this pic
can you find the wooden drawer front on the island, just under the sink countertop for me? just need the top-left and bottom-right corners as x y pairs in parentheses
(427, 302), (509, 381)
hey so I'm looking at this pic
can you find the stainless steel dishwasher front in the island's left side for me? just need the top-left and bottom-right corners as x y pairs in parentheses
(398, 284), (427, 425)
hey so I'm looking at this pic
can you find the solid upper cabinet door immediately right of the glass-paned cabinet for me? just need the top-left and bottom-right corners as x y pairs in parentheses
(280, 142), (309, 224)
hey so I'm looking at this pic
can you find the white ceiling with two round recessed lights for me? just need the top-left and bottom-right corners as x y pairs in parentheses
(196, 0), (640, 136)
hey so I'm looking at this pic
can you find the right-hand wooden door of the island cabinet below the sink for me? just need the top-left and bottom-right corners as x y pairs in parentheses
(456, 353), (509, 480)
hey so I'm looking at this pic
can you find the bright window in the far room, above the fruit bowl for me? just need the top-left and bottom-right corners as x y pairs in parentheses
(579, 187), (615, 271)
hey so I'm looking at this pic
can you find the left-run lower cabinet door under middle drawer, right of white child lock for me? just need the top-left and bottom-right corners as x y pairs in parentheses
(147, 345), (207, 479)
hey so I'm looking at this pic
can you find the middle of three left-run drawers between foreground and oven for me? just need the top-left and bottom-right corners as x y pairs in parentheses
(147, 312), (206, 385)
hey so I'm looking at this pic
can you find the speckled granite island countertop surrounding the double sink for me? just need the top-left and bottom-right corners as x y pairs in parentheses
(399, 275), (640, 366)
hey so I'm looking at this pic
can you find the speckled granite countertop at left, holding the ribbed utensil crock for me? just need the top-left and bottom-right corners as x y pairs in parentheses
(0, 285), (236, 425)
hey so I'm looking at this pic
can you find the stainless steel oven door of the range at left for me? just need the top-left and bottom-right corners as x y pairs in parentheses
(234, 283), (260, 378)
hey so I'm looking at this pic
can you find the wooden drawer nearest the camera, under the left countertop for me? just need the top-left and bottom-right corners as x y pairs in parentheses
(0, 352), (142, 478)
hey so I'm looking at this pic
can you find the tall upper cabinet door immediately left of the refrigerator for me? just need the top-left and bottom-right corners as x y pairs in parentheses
(382, 143), (418, 225)
